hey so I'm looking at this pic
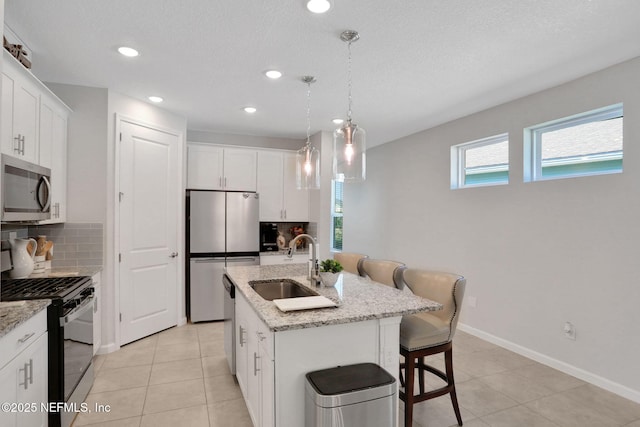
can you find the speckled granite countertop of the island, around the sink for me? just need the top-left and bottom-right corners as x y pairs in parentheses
(226, 264), (442, 332)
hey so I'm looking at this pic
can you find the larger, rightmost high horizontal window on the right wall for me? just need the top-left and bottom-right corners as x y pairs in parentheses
(524, 104), (623, 182)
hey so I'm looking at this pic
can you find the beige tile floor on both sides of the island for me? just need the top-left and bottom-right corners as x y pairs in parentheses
(73, 322), (640, 427)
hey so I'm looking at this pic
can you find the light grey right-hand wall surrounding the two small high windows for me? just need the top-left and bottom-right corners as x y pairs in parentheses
(344, 58), (640, 402)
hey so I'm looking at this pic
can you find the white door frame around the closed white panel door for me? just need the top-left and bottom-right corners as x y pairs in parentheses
(112, 113), (187, 350)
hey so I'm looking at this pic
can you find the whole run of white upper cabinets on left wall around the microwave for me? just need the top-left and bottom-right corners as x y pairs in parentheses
(0, 49), (71, 224)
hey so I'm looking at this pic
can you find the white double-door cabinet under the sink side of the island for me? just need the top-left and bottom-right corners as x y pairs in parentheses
(236, 292), (275, 427)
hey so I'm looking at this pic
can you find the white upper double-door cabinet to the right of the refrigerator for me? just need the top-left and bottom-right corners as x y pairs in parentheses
(257, 150), (309, 222)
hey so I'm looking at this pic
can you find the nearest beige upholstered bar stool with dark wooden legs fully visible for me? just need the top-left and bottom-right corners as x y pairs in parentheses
(400, 268), (466, 427)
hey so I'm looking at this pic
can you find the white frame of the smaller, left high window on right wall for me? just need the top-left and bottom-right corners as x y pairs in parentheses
(451, 132), (510, 190)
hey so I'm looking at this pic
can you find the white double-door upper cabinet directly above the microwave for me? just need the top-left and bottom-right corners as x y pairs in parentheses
(1, 49), (41, 163)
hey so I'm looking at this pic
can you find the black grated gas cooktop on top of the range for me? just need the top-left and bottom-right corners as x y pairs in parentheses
(0, 276), (91, 301)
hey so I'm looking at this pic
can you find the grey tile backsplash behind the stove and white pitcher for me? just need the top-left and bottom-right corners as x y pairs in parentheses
(1, 223), (104, 267)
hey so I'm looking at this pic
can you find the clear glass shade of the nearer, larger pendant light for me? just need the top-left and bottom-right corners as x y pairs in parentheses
(333, 121), (367, 182)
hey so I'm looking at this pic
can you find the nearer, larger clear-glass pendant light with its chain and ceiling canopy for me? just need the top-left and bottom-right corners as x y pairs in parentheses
(333, 30), (366, 182)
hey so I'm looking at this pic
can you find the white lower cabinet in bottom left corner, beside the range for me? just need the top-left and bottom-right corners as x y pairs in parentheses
(0, 309), (48, 427)
